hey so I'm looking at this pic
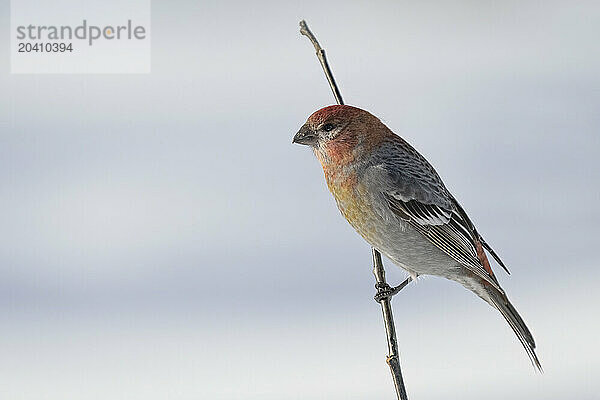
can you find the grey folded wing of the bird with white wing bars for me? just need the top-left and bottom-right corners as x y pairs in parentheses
(370, 137), (501, 290)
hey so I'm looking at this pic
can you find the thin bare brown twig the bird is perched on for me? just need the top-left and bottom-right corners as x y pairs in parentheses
(300, 20), (410, 400)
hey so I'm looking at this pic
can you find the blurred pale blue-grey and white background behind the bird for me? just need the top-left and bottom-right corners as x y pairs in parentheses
(0, 0), (600, 400)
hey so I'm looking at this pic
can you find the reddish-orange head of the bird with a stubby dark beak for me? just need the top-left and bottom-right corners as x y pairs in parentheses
(292, 105), (387, 164)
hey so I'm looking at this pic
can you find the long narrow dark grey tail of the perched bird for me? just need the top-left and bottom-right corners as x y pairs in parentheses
(482, 285), (543, 372)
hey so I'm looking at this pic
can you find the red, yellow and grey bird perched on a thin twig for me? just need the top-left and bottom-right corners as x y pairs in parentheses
(292, 105), (542, 372)
